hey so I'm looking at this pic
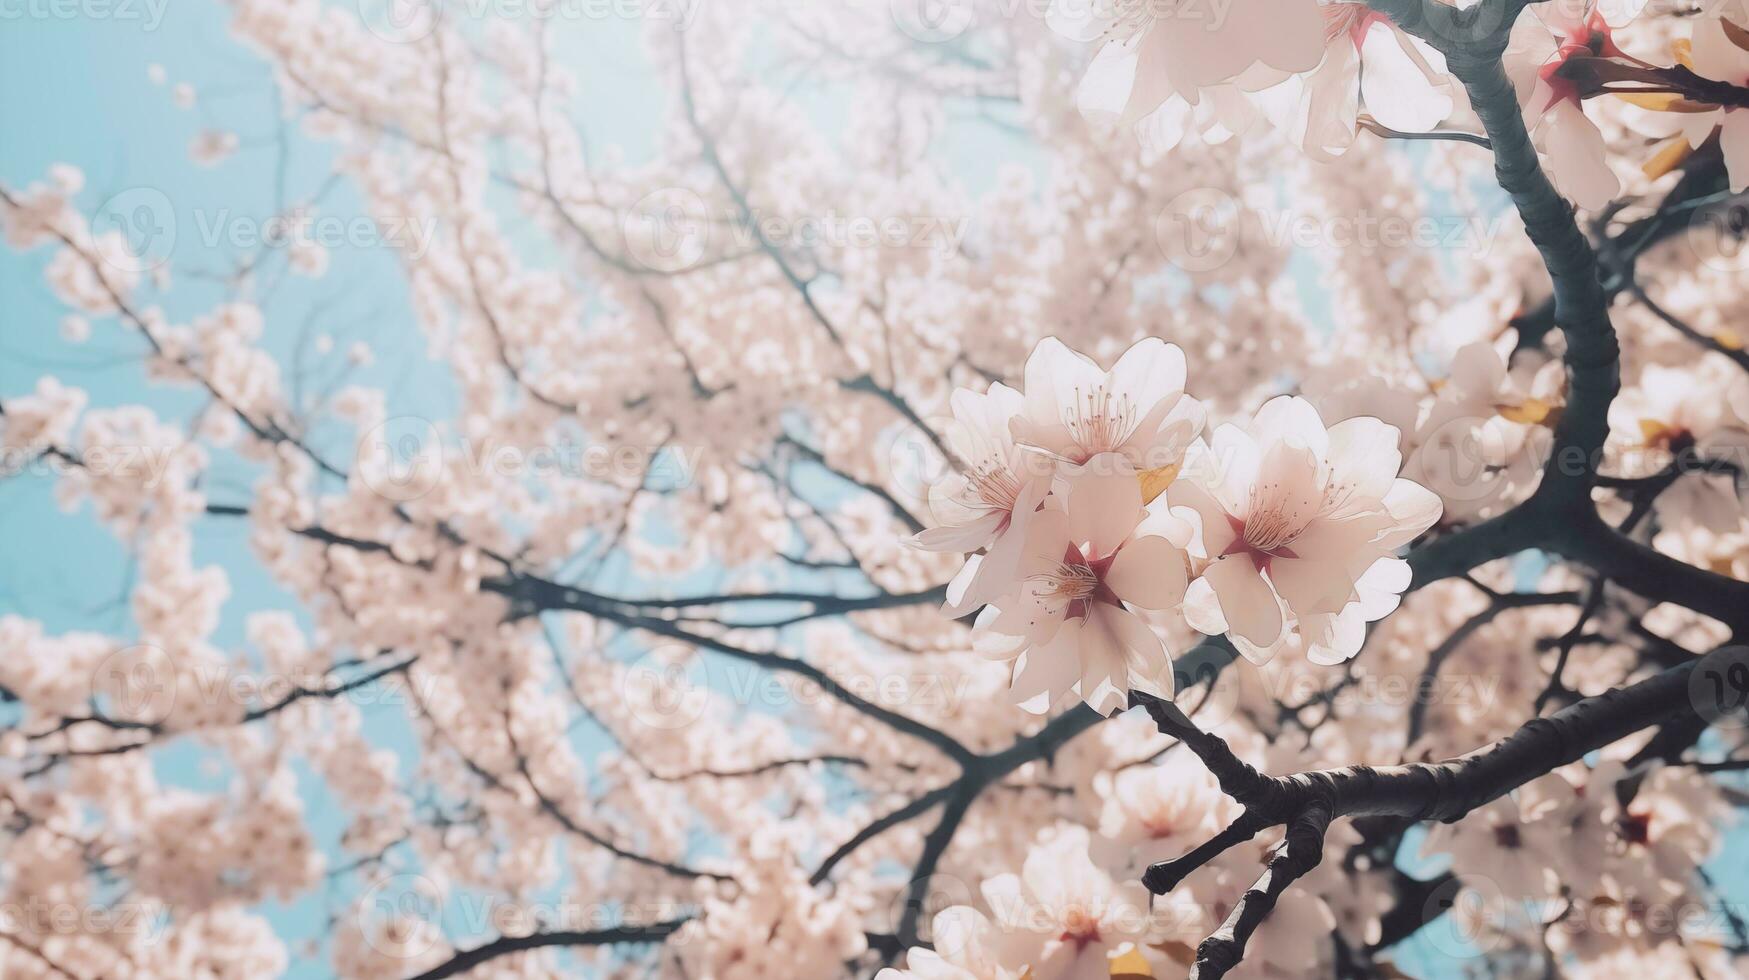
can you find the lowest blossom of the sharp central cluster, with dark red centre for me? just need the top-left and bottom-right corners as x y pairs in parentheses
(978, 453), (1186, 714)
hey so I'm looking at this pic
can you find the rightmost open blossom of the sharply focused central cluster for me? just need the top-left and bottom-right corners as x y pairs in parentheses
(1167, 396), (1441, 658)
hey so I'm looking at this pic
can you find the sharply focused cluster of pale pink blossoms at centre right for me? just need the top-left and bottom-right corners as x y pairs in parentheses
(915, 338), (1443, 714)
